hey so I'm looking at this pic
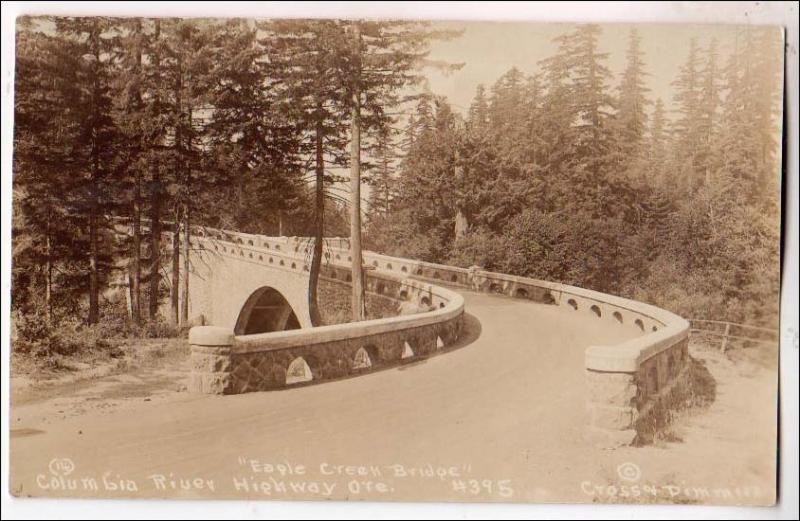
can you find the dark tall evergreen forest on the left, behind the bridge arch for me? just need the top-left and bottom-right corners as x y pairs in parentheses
(13, 17), (455, 342)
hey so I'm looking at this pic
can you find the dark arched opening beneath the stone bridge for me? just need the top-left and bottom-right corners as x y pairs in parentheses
(234, 286), (300, 335)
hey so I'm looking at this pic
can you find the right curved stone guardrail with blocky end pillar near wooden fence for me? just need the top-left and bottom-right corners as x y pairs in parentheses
(278, 239), (689, 447)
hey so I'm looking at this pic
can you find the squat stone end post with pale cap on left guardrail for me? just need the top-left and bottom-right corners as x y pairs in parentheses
(189, 326), (234, 394)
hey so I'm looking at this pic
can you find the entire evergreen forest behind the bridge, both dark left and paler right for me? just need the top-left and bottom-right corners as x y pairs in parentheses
(12, 17), (782, 354)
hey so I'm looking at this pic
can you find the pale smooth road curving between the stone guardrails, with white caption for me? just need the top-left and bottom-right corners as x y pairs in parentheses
(11, 293), (775, 503)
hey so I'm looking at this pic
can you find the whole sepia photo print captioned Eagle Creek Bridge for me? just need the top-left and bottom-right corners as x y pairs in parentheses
(3, 1), (797, 516)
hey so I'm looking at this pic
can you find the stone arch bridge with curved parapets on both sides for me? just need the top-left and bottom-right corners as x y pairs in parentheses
(166, 227), (691, 446)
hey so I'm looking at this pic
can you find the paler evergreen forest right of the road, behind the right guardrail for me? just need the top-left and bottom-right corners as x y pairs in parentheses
(367, 25), (782, 326)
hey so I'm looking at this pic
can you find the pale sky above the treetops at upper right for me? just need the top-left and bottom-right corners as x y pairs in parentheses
(425, 22), (772, 118)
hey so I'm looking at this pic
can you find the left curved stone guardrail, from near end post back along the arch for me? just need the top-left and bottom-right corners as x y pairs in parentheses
(184, 228), (464, 394)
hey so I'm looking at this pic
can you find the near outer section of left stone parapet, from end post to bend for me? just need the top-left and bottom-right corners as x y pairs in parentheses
(189, 296), (463, 394)
